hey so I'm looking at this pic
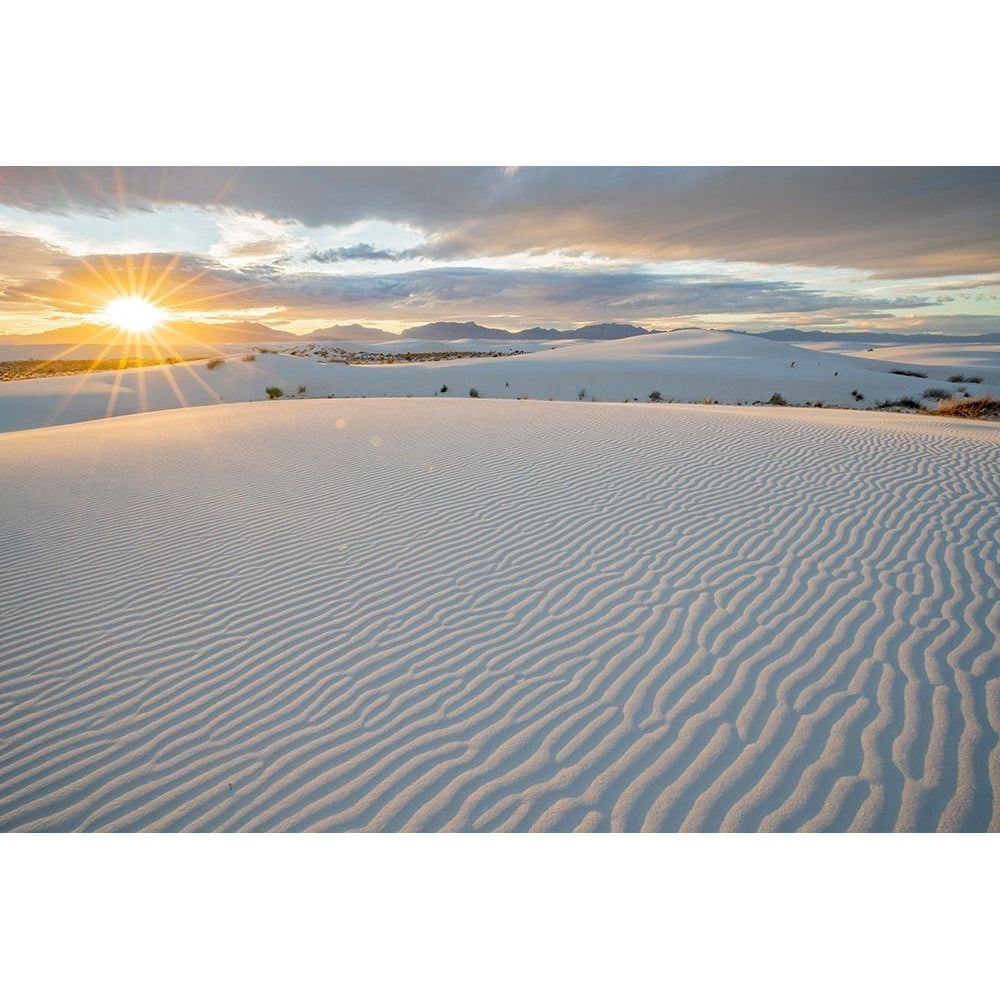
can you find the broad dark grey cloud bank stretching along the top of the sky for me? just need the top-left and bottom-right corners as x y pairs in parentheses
(0, 167), (1000, 277)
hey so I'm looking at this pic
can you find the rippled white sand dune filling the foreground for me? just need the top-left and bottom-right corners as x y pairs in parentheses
(0, 399), (1000, 830)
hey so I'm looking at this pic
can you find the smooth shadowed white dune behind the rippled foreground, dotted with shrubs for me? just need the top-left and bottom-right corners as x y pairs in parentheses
(0, 330), (1000, 431)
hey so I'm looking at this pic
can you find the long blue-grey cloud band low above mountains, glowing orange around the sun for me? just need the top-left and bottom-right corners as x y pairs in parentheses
(0, 243), (984, 326)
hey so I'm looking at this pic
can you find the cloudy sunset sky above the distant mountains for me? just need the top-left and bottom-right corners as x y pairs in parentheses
(0, 166), (1000, 336)
